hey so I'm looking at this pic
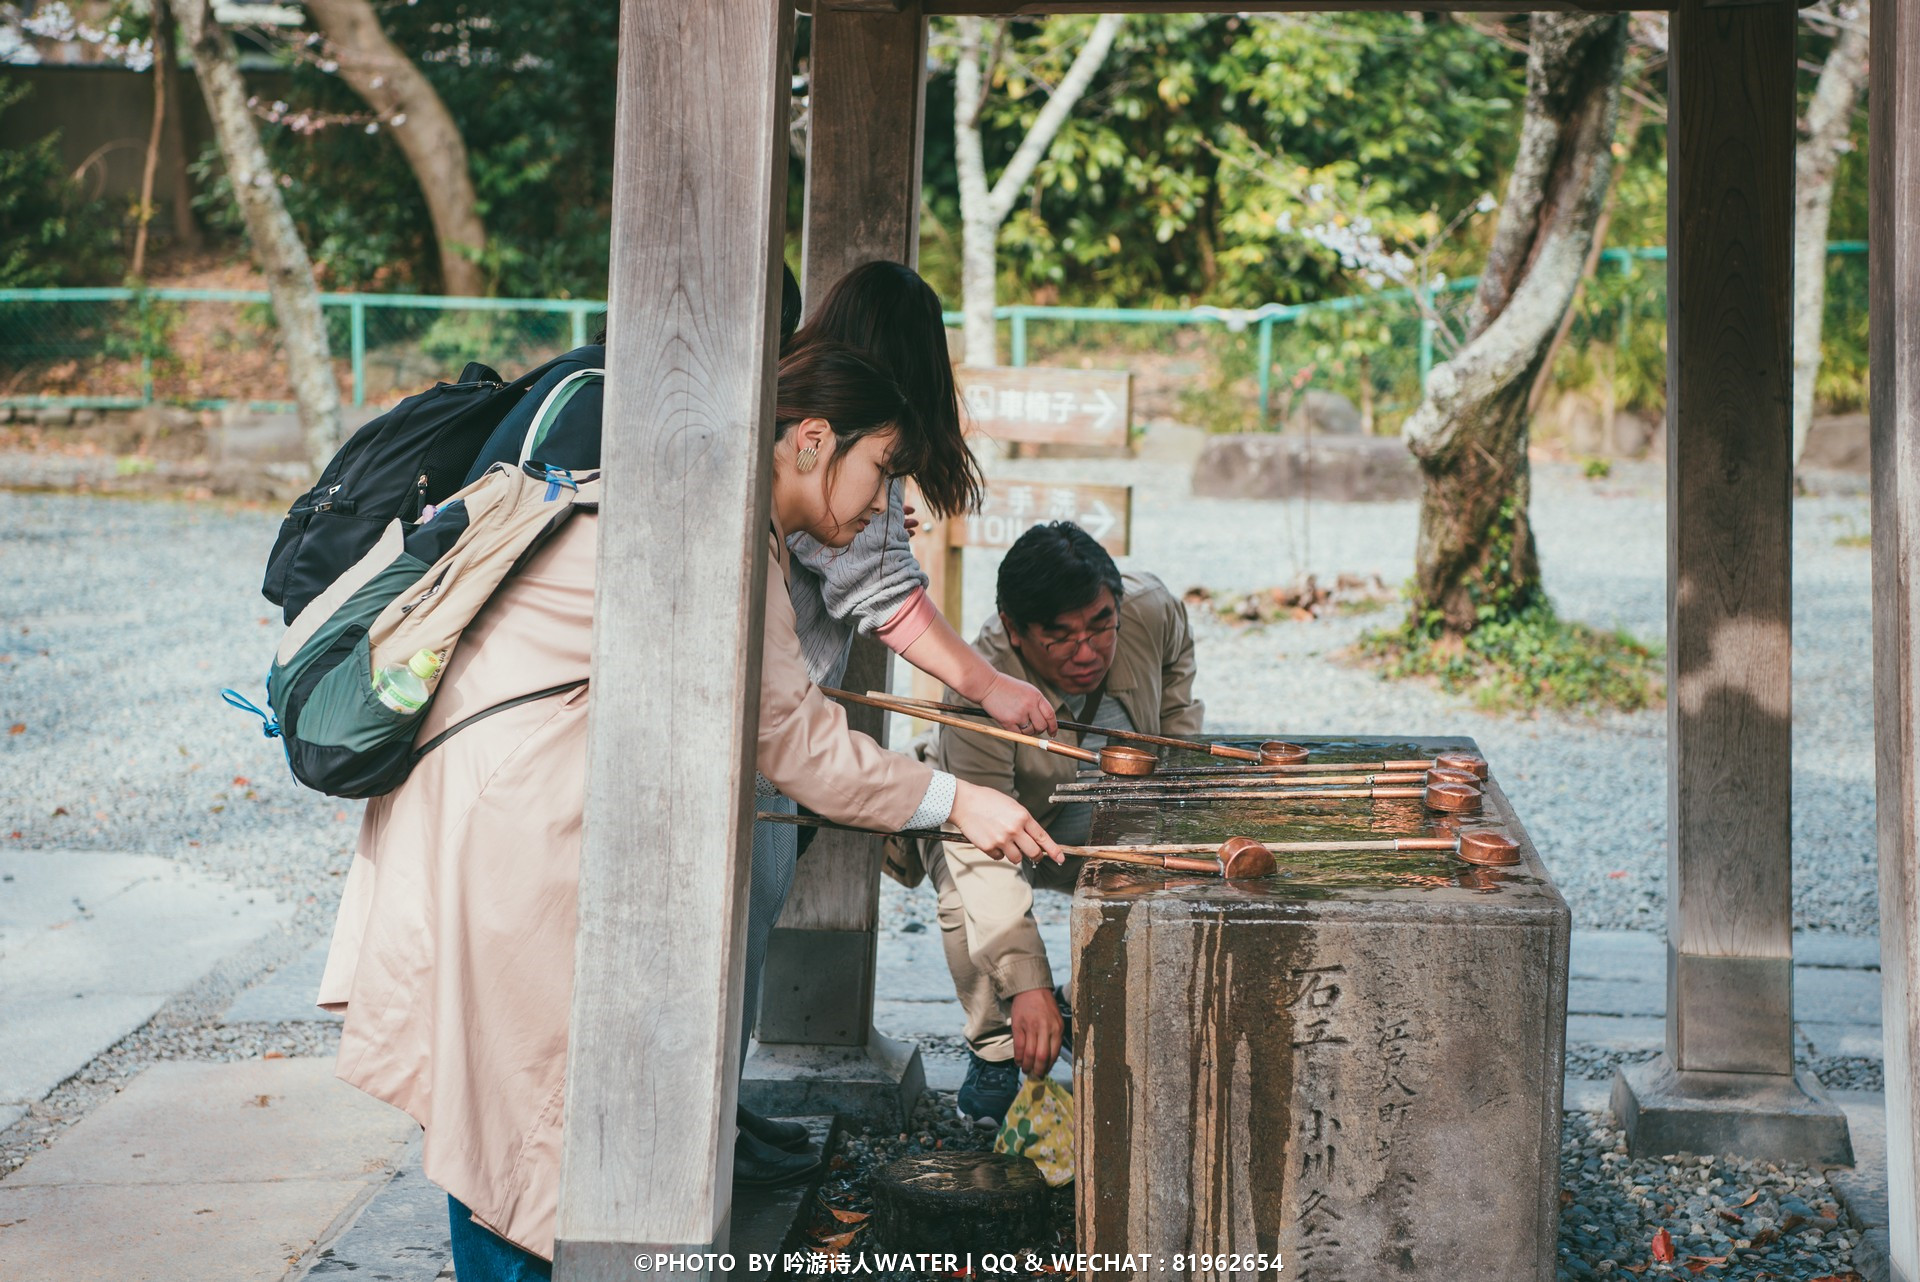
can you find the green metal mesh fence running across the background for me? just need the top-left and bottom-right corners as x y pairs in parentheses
(0, 242), (1866, 430)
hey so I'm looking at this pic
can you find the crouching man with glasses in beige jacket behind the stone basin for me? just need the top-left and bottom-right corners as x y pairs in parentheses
(910, 522), (1202, 1127)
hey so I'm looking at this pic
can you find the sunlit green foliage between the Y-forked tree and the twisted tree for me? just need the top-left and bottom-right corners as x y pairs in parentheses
(925, 13), (1524, 305)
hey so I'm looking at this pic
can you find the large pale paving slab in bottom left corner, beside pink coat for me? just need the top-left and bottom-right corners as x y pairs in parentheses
(0, 1059), (419, 1282)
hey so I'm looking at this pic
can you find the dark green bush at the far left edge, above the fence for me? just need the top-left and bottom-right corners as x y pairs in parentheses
(0, 79), (121, 290)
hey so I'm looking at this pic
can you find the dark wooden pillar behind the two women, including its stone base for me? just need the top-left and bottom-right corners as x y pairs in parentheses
(741, 0), (927, 1125)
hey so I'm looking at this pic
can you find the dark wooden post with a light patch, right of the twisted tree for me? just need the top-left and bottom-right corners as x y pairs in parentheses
(1667, 6), (1795, 1075)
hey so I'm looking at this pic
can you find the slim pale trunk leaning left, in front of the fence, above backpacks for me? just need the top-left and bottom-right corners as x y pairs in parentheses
(177, 0), (340, 468)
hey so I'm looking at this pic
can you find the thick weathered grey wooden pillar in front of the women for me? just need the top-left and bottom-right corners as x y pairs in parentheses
(555, 0), (793, 1282)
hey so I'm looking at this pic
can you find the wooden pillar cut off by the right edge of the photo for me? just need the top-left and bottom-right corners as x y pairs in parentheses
(1868, 0), (1920, 1282)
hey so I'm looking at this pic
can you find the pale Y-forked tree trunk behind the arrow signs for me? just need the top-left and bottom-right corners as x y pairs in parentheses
(954, 13), (1127, 365)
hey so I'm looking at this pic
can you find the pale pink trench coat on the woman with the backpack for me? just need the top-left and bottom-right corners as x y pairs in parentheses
(319, 516), (931, 1259)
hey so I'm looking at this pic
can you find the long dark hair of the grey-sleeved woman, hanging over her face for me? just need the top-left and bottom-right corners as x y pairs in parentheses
(789, 261), (983, 516)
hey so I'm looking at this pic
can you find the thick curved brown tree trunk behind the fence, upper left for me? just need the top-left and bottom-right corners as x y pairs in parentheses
(307, 0), (486, 294)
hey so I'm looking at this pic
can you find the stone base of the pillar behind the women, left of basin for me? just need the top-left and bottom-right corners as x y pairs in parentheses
(739, 1029), (927, 1130)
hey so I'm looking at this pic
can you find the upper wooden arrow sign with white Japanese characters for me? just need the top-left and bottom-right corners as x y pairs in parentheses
(954, 365), (1133, 447)
